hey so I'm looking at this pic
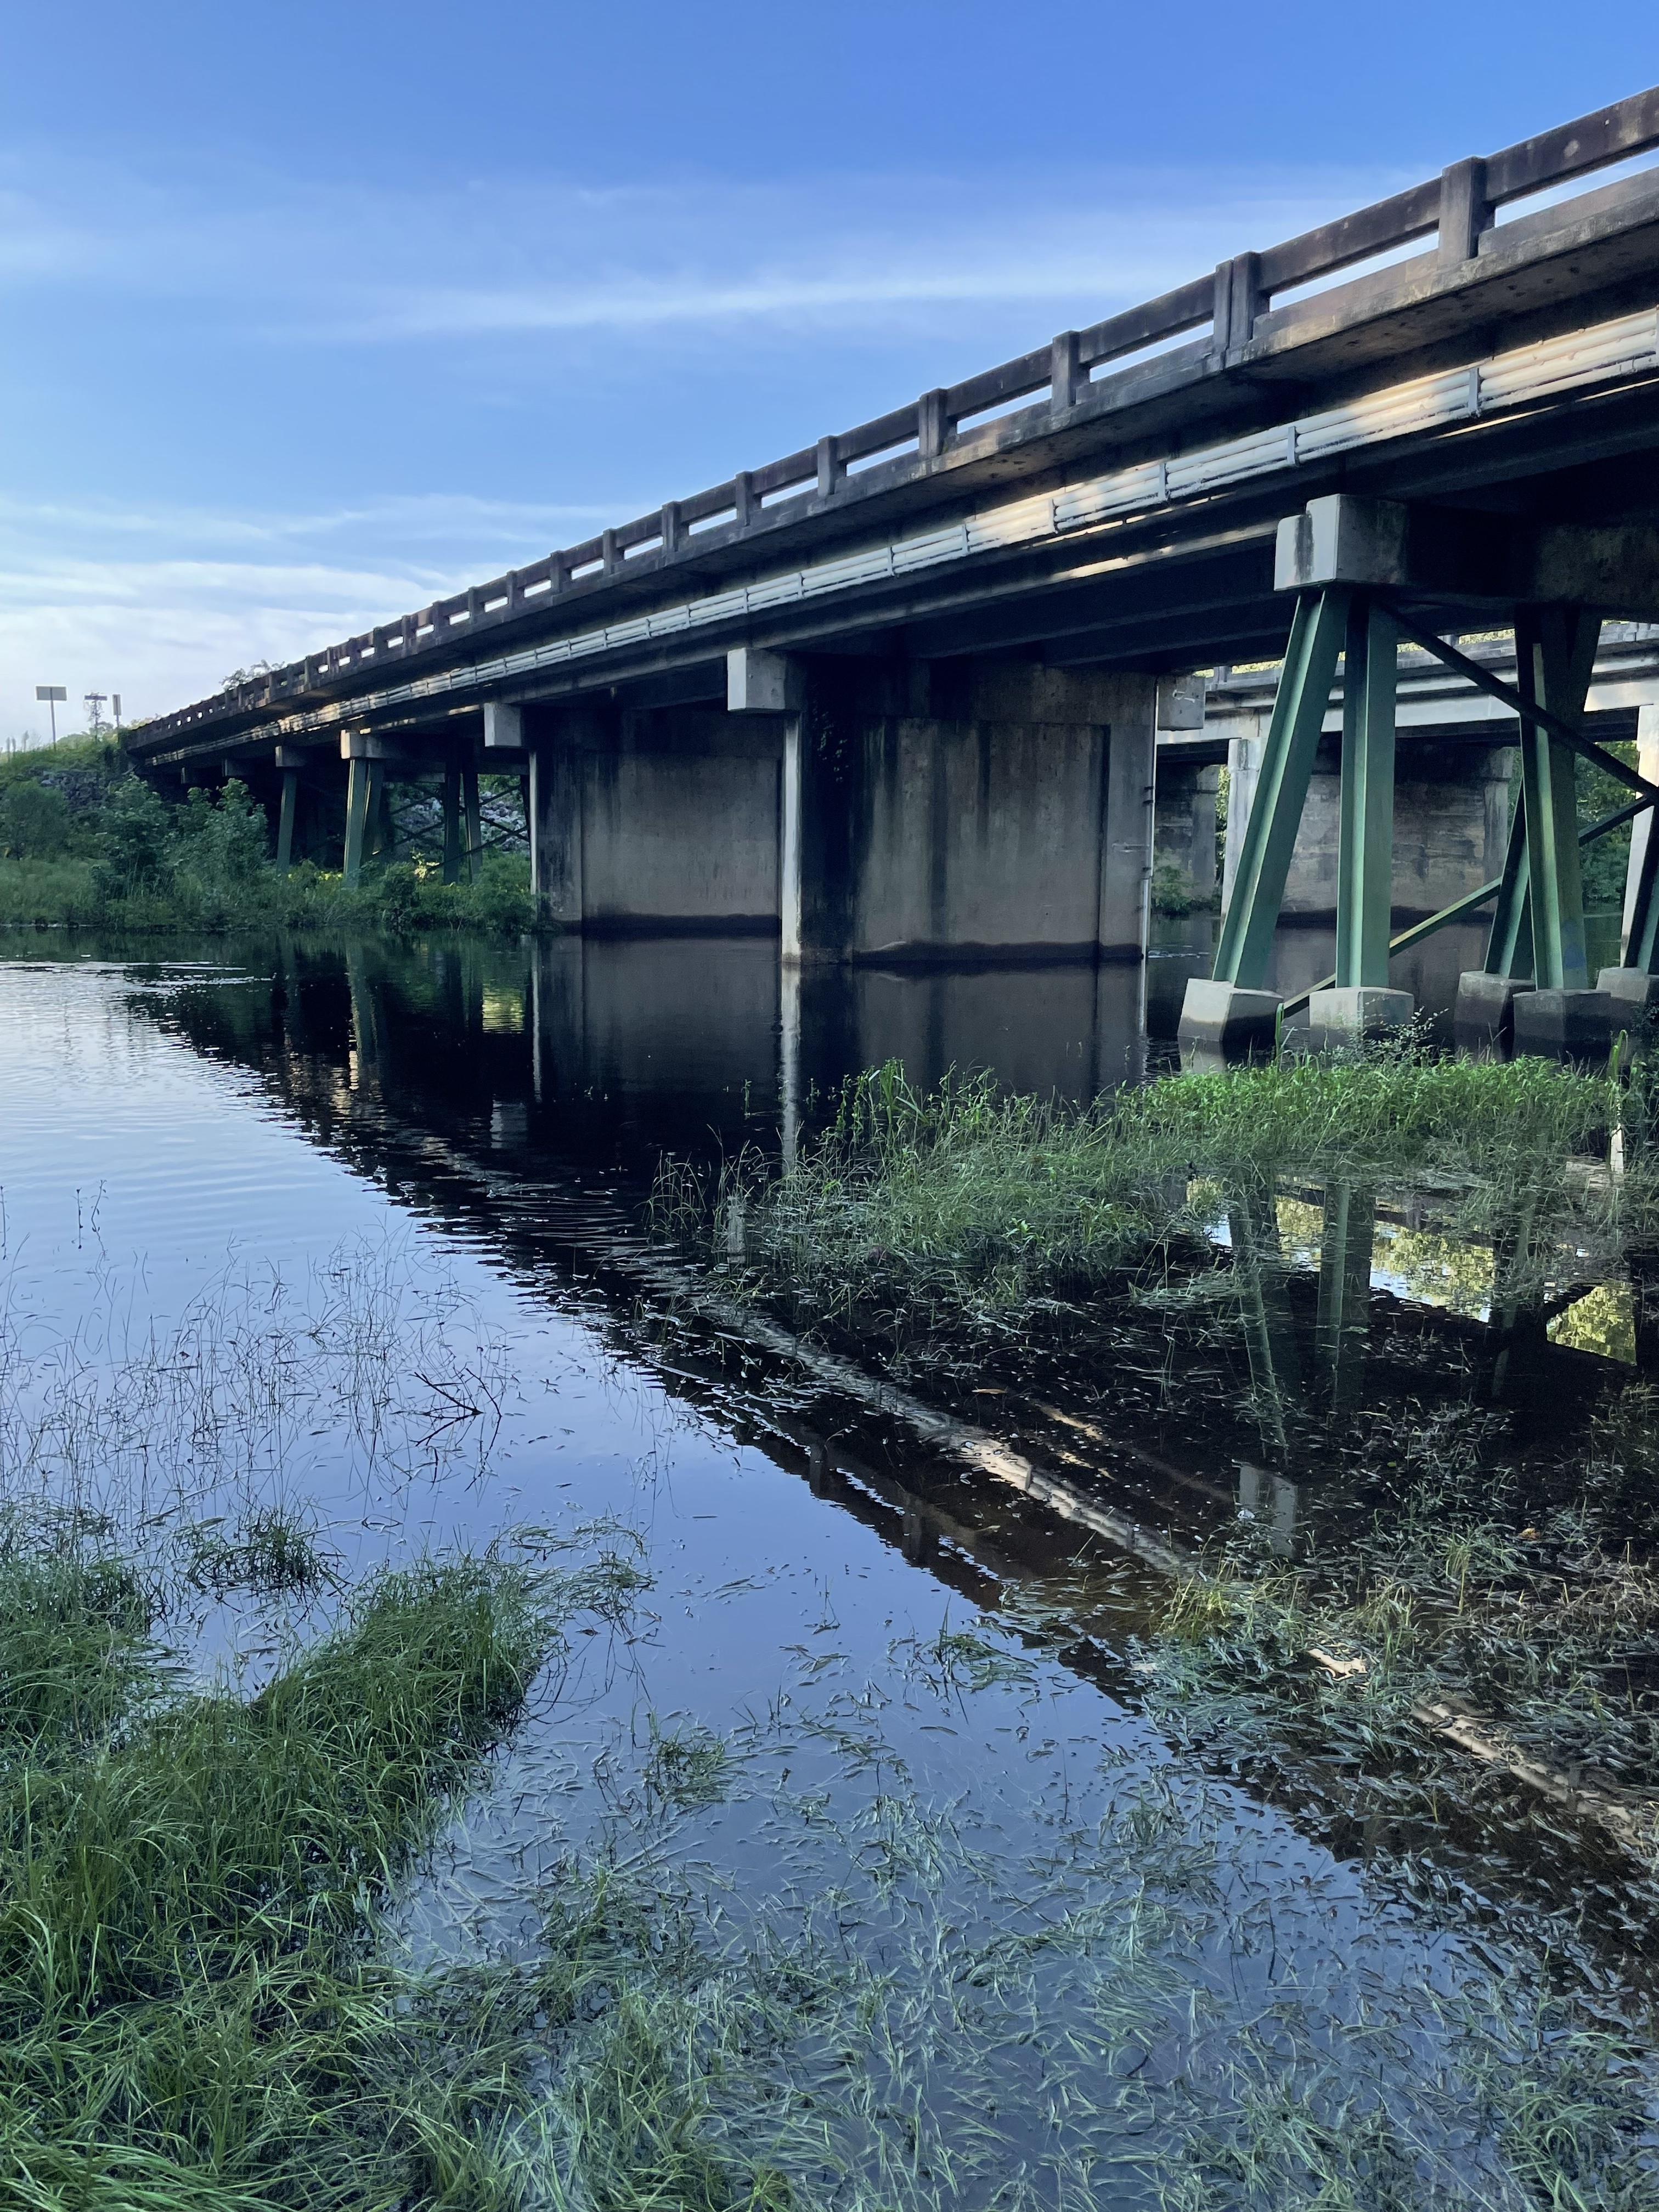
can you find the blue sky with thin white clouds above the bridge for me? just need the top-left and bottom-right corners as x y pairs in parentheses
(0, 0), (1659, 743)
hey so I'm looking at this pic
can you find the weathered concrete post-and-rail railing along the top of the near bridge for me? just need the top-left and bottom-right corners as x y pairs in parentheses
(146, 88), (1659, 739)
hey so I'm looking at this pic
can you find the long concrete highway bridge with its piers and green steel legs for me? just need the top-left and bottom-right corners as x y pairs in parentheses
(128, 88), (1659, 1048)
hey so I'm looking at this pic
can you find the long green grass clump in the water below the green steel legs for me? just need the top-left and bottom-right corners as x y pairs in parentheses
(676, 1051), (1623, 1327)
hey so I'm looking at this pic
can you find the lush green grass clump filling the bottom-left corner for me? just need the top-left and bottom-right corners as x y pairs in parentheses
(0, 1542), (681, 2212)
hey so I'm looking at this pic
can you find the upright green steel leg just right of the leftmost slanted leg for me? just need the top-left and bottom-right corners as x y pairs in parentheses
(1336, 595), (1400, 991)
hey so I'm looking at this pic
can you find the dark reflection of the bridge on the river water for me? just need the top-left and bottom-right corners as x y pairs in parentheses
(168, 943), (1659, 1610)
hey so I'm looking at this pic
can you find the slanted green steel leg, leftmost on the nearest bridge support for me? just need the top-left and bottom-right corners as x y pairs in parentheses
(1212, 586), (1350, 991)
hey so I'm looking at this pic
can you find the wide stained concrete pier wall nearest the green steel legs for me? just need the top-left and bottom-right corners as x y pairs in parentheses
(728, 648), (1157, 967)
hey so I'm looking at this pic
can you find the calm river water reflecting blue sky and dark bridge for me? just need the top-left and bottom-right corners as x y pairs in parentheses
(0, 927), (1652, 2208)
